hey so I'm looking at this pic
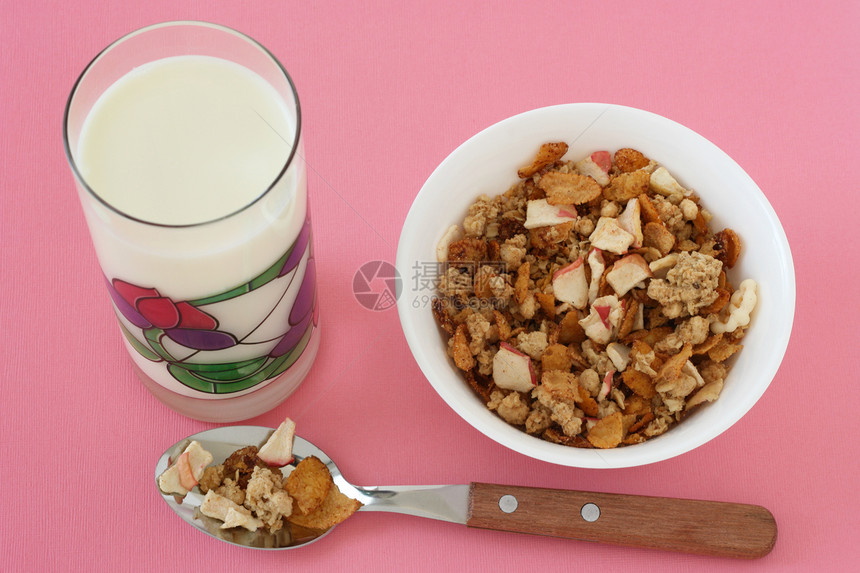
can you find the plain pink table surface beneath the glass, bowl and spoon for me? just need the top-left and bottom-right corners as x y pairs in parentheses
(0, 0), (860, 571)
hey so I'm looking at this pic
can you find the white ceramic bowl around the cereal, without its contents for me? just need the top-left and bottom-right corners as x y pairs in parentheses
(397, 103), (795, 468)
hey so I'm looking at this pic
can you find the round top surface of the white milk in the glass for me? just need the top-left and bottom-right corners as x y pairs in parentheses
(78, 56), (295, 225)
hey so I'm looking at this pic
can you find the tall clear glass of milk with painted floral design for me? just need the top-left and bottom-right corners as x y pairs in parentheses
(63, 22), (319, 422)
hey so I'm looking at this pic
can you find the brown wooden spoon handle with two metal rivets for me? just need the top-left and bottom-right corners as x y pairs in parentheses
(466, 483), (776, 559)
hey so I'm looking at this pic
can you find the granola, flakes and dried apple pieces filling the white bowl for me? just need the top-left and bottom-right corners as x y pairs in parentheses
(432, 143), (757, 448)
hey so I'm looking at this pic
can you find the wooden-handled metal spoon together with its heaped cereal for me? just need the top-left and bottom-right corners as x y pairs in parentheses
(155, 419), (777, 559)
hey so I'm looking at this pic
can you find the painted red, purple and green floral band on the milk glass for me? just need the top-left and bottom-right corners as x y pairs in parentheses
(111, 214), (319, 394)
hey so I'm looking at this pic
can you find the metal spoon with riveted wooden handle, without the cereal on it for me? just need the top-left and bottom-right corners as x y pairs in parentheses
(155, 426), (776, 559)
